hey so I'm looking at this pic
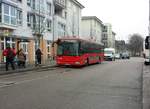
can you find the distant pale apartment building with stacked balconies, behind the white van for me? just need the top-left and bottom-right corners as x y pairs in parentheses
(102, 23), (116, 48)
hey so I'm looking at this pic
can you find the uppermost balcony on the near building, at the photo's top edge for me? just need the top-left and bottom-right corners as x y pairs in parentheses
(54, 0), (66, 10)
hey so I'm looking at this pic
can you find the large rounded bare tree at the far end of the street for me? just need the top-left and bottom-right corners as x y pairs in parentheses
(129, 33), (144, 56)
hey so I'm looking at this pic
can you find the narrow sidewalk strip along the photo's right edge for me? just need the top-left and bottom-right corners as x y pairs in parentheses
(142, 65), (150, 109)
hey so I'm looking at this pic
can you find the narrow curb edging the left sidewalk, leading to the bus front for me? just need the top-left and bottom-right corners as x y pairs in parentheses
(0, 65), (57, 75)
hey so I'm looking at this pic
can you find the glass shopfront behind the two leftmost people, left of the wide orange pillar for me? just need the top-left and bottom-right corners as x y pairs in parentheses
(0, 30), (33, 62)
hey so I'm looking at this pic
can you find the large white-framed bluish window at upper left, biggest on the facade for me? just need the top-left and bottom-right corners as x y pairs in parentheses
(4, 4), (16, 25)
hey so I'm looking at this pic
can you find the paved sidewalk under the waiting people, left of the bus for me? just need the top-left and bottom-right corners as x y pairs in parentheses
(0, 60), (56, 75)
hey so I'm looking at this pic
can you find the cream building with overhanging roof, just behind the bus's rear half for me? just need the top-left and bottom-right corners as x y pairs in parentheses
(81, 16), (104, 43)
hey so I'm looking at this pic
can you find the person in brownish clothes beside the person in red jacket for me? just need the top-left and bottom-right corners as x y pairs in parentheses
(17, 48), (26, 68)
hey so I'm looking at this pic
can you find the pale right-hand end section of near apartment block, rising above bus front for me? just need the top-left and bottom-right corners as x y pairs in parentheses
(54, 0), (84, 40)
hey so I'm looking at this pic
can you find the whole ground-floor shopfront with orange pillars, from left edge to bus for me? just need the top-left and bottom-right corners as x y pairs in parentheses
(0, 29), (53, 64)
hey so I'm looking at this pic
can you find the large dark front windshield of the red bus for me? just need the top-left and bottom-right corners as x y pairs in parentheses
(57, 41), (79, 56)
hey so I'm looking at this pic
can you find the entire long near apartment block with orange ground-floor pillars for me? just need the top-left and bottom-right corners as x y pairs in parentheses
(0, 0), (84, 63)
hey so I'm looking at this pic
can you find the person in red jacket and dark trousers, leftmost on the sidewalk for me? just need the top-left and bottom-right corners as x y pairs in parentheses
(3, 46), (16, 71)
